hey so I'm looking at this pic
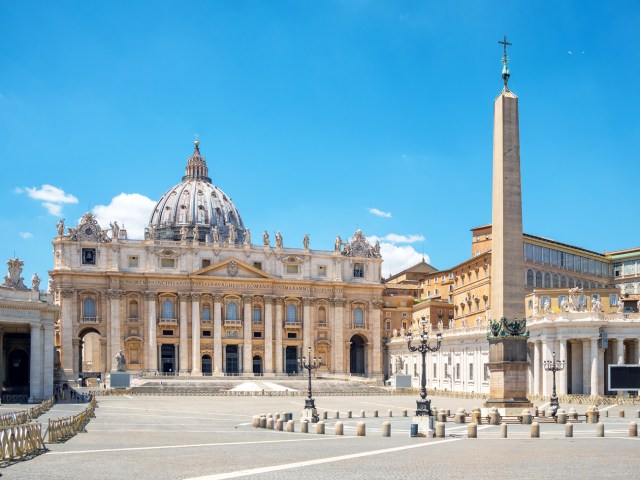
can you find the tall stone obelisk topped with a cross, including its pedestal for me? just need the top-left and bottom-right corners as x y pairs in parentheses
(485, 36), (532, 415)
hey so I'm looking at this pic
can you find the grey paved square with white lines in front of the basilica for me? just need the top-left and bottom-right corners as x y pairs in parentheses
(0, 395), (640, 480)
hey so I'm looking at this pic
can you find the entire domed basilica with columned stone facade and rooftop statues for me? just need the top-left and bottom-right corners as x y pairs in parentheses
(50, 142), (384, 380)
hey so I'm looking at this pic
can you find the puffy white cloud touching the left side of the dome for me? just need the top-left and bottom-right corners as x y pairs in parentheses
(93, 193), (156, 238)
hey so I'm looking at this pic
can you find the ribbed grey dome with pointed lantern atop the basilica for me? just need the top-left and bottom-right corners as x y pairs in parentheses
(145, 141), (245, 243)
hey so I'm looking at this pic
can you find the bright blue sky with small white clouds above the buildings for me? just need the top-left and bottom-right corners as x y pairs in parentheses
(0, 0), (640, 279)
